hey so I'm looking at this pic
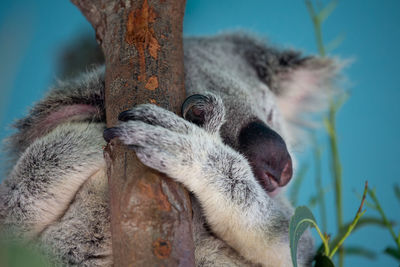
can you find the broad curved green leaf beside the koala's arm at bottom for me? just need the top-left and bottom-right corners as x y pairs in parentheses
(289, 206), (317, 267)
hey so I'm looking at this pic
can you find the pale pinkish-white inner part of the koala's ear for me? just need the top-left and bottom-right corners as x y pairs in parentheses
(273, 57), (343, 126)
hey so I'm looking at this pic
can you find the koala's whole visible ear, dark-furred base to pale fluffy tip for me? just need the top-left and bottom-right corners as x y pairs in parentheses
(241, 39), (345, 124)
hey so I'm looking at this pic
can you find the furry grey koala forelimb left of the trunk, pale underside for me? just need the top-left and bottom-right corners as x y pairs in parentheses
(0, 123), (104, 237)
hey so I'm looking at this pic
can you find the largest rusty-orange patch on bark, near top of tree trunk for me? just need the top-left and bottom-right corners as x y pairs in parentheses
(125, 0), (160, 82)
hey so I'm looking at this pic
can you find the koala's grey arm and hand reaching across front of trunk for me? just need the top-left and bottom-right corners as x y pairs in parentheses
(104, 101), (312, 266)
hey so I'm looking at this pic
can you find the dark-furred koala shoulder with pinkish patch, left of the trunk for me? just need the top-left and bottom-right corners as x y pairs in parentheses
(5, 67), (105, 160)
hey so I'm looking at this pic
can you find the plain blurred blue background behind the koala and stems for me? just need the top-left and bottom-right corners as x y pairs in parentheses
(0, 0), (400, 267)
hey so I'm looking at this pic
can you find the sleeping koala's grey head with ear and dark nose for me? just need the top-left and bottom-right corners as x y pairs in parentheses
(183, 35), (340, 196)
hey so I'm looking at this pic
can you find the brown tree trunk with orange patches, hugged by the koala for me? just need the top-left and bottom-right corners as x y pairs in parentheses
(72, 0), (194, 266)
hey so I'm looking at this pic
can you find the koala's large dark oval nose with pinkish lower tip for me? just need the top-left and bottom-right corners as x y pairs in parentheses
(239, 121), (293, 196)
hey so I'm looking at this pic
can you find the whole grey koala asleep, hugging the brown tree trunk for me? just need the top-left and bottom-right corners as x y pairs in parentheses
(0, 33), (340, 267)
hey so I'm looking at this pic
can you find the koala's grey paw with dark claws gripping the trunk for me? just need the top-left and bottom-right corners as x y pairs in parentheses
(103, 95), (224, 180)
